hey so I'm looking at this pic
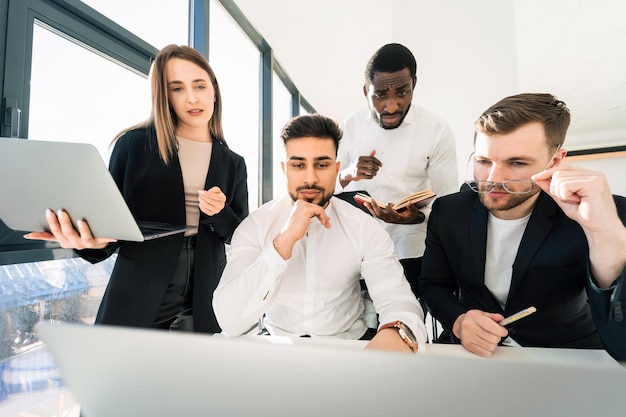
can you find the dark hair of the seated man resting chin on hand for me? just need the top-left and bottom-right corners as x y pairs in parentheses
(280, 113), (343, 156)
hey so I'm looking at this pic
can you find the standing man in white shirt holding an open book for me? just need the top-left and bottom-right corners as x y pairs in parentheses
(335, 43), (459, 294)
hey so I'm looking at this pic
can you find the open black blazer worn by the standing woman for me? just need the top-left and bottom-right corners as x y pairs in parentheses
(77, 129), (248, 333)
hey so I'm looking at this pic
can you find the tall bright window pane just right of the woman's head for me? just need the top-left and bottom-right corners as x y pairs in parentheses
(209, 1), (260, 209)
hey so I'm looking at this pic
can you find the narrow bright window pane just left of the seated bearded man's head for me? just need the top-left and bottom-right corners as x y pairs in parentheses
(272, 72), (291, 197)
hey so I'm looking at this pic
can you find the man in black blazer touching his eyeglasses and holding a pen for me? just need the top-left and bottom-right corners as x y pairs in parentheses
(419, 94), (626, 360)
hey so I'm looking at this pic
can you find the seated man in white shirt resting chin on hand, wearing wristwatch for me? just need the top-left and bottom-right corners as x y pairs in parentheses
(213, 115), (426, 351)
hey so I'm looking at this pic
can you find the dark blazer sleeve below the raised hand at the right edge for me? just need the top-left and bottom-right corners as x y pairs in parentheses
(589, 269), (626, 361)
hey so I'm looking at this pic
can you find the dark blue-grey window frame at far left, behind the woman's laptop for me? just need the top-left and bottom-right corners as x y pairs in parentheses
(0, 0), (157, 265)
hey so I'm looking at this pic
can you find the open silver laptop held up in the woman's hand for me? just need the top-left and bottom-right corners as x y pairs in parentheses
(0, 138), (192, 242)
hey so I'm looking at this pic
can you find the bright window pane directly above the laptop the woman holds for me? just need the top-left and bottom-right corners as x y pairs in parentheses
(28, 22), (150, 164)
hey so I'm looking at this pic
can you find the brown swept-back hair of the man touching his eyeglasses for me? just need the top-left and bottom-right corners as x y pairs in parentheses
(474, 93), (571, 149)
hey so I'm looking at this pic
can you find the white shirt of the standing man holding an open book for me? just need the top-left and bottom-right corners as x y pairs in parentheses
(335, 103), (459, 259)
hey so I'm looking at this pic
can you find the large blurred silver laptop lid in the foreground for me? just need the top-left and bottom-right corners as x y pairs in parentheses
(36, 322), (626, 417)
